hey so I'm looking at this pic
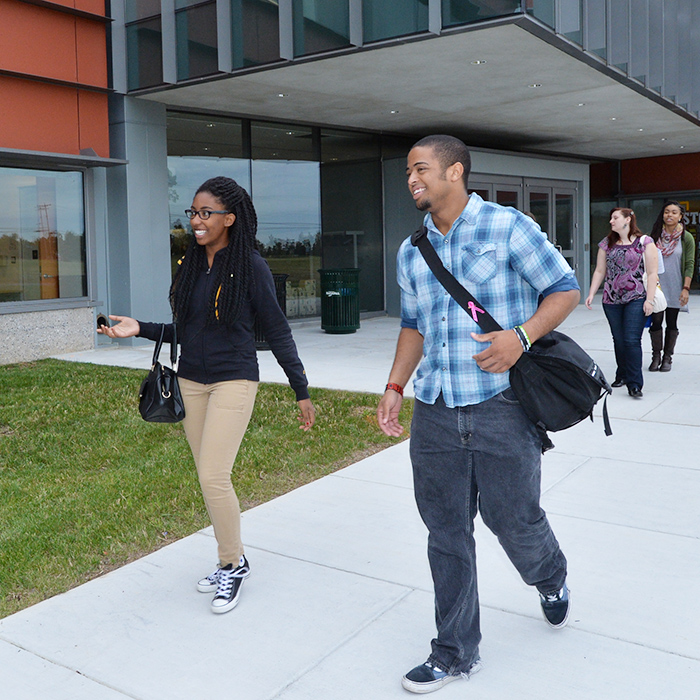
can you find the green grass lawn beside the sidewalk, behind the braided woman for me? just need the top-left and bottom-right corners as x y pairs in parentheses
(0, 360), (413, 617)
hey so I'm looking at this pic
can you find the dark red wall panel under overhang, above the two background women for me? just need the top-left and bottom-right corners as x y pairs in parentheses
(621, 153), (700, 194)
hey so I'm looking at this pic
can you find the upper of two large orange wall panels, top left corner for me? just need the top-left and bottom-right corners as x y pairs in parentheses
(0, 0), (77, 81)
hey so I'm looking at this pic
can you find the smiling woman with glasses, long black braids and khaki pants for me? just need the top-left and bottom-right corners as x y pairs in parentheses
(101, 177), (315, 613)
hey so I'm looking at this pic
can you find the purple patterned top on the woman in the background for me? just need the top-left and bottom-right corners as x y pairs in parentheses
(598, 236), (651, 304)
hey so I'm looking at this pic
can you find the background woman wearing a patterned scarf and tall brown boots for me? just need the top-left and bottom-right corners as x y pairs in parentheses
(649, 200), (695, 372)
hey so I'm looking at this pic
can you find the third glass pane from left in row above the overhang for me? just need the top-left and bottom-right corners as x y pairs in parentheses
(231, 0), (280, 68)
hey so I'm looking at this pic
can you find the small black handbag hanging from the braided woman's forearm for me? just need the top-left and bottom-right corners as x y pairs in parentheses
(139, 324), (185, 423)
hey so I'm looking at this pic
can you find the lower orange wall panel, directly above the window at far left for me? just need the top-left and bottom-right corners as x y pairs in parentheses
(0, 76), (80, 154)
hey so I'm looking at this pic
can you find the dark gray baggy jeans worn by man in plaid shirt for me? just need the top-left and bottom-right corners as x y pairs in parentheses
(410, 389), (566, 674)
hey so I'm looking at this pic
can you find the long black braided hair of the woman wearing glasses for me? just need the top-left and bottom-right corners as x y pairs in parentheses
(170, 177), (258, 327)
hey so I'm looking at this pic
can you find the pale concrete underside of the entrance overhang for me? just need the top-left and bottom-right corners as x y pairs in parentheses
(137, 21), (700, 159)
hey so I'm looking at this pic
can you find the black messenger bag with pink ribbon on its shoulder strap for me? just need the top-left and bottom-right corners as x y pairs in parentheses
(411, 226), (612, 452)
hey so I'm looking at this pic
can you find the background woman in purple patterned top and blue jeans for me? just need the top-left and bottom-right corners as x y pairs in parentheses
(586, 208), (659, 399)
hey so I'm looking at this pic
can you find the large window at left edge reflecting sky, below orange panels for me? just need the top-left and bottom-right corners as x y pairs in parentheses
(0, 167), (87, 302)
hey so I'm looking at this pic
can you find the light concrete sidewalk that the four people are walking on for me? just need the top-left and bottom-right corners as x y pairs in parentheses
(0, 308), (700, 700)
